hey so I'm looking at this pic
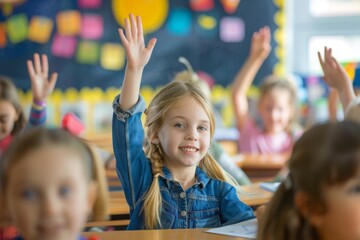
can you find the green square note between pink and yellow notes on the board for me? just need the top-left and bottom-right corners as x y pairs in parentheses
(76, 41), (99, 64)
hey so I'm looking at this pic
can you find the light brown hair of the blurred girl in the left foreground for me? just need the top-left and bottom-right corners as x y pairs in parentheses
(0, 127), (108, 221)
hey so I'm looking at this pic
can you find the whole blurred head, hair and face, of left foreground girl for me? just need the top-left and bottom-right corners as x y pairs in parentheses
(0, 127), (107, 240)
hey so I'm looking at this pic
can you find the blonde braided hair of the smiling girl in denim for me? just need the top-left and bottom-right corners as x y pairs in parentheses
(143, 81), (237, 229)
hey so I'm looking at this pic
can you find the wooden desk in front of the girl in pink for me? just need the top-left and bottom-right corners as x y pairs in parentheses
(233, 154), (289, 182)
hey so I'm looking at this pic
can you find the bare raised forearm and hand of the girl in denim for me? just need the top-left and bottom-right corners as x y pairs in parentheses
(119, 14), (156, 111)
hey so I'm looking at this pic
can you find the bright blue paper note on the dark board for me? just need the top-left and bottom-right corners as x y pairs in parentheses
(166, 8), (192, 36)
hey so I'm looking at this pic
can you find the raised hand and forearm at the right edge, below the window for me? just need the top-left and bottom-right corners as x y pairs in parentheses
(318, 47), (360, 122)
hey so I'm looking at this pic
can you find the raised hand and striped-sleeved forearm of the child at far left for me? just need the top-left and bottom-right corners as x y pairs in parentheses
(26, 53), (58, 127)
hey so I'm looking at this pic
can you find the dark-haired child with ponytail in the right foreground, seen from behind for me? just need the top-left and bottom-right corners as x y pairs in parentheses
(257, 120), (360, 240)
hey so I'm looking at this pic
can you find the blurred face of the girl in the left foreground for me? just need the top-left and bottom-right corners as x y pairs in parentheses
(5, 145), (96, 240)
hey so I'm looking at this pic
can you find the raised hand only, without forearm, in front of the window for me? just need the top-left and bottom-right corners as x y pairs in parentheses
(318, 47), (351, 92)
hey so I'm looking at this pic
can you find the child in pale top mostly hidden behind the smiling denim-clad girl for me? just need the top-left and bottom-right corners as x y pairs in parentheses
(173, 57), (251, 185)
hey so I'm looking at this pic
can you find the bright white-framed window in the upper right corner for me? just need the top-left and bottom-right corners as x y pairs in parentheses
(285, 0), (360, 75)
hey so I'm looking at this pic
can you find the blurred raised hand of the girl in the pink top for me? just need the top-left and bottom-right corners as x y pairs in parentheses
(249, 26), (271, 60)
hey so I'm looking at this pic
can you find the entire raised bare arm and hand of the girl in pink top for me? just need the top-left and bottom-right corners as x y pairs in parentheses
(232, 27), (271, 131)
